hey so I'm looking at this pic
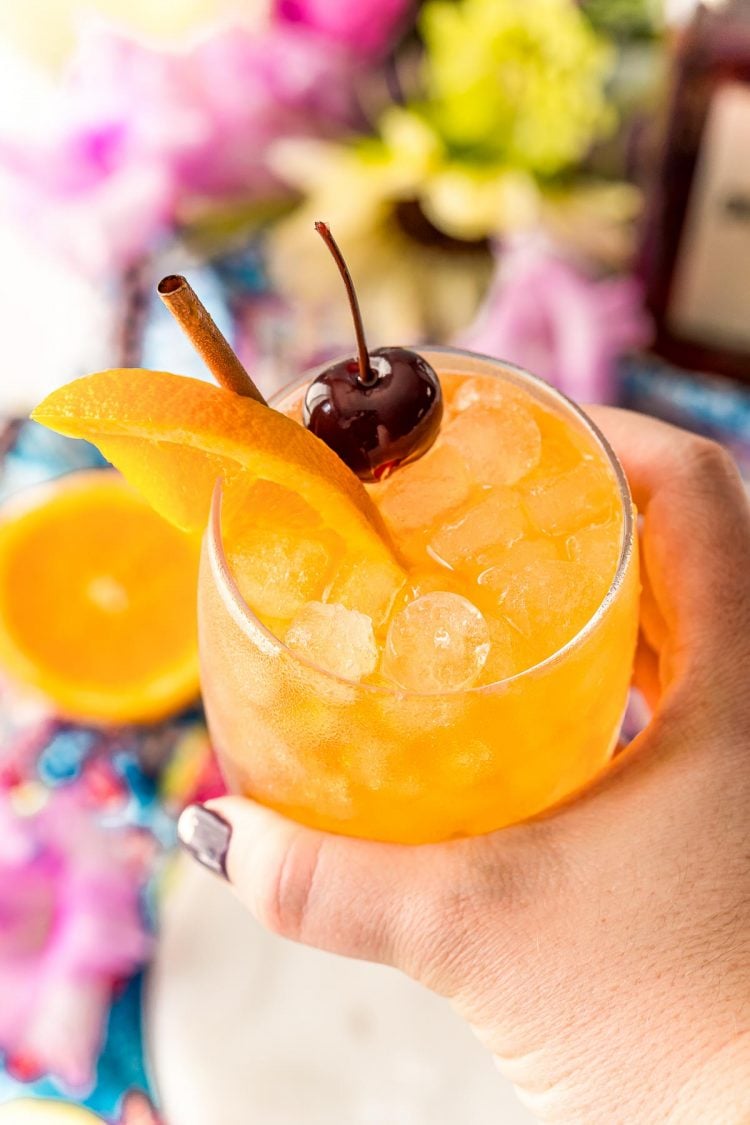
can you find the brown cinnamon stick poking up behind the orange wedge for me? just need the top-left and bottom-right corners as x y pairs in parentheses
(156, 273), (268, 406)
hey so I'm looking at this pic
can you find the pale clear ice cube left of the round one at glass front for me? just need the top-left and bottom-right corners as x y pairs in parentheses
(284, 602), (378, 682)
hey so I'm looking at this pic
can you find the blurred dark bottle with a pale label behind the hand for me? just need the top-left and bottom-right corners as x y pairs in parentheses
(641, 0), (750, 380)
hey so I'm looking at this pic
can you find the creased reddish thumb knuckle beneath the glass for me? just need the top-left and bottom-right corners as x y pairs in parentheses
(255, 829), (322, 942)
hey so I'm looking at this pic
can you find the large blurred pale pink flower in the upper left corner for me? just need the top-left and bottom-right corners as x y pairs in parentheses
(0, 23), (354, 273)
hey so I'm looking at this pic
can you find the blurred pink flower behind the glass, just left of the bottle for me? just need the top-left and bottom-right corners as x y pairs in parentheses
(458, 241), (650, 403)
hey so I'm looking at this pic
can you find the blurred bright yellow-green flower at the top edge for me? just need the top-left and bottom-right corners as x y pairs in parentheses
(419, 0), (613, 177)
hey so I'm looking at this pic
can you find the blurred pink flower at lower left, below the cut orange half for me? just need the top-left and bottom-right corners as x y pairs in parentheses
(0, 783), (151, 1091)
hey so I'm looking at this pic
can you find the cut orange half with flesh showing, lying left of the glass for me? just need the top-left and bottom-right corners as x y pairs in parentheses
(0, 471), (198, 722)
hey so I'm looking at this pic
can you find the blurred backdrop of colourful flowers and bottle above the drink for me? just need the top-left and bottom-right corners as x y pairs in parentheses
(0, 0), (750, 459)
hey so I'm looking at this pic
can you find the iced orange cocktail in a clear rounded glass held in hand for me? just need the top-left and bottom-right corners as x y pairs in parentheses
(199, 349), (639, 843)
